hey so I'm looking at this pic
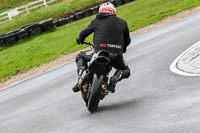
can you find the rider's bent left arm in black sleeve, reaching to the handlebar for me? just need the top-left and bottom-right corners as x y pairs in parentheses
(79, 19), (95, 41)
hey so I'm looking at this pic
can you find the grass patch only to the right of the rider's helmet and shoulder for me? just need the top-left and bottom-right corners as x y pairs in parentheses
(118, 0), (200, 31)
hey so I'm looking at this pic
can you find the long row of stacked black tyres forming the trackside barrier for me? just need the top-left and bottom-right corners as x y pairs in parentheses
(0, 0), (133, 47)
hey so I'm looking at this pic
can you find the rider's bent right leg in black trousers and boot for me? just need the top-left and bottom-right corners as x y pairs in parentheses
(109, 55), (131, 92)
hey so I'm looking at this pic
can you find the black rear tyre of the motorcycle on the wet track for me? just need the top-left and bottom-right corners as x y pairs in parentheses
(88, 74), (103, 113)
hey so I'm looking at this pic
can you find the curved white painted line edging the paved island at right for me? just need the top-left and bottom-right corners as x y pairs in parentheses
(170, 41), (200, 76)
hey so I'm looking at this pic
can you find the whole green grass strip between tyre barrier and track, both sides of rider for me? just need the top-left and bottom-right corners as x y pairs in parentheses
(0, 0), (200, 82)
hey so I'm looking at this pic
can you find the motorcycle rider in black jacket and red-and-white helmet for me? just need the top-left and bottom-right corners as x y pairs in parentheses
(72, 2), (131, 92)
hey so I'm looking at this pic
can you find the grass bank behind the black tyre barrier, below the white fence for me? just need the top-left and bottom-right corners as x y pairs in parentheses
(0, 0), (103, 34)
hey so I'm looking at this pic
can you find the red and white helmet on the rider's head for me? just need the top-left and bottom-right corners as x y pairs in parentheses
(99, 2), (117, 15)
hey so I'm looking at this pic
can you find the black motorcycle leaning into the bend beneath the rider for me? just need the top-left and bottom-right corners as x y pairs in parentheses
(79, 42), (112, 113)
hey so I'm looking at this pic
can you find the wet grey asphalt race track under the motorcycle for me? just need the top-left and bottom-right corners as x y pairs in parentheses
(0, 13), (200, 133)
